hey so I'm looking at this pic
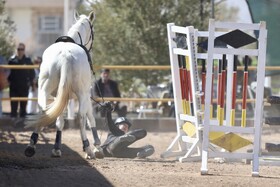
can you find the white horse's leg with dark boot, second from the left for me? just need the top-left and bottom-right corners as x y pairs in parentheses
(52, 114), (64, 157)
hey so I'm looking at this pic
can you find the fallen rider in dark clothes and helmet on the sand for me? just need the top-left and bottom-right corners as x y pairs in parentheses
(96, 102), (155, 158)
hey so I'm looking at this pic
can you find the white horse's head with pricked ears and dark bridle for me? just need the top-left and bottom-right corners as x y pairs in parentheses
(68, 11), (95, 51)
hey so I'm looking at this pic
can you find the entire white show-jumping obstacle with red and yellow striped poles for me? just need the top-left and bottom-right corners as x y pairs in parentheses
(161, 20), (267, 176)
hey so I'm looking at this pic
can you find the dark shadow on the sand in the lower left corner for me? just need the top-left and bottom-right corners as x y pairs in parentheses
(0, 121), (113, 187)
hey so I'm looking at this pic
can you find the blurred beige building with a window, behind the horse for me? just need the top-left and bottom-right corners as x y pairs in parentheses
(6, 0), (80, 56)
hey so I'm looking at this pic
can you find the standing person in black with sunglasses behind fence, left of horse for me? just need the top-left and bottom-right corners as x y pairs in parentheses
(8, 43), (35, 118)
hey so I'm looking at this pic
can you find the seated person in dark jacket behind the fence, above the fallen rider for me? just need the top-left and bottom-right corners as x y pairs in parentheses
(93, 69), (127, 117)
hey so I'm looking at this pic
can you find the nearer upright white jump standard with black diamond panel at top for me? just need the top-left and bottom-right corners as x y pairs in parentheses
(201, 20), (267, 176)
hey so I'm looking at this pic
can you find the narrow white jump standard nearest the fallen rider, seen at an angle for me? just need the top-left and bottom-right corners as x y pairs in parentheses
(161, 23), (229, 162)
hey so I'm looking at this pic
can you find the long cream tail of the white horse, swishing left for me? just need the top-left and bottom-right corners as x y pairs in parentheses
(26, 53), (73, 128)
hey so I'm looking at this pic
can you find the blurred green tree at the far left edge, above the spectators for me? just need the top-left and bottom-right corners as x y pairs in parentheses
(0, 0), (15, 59)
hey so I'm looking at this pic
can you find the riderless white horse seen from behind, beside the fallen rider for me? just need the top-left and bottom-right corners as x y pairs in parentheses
(25, 12), (100, 158)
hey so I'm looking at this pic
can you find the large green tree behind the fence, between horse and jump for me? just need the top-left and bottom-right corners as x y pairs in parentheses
(82, 0), (210, 91)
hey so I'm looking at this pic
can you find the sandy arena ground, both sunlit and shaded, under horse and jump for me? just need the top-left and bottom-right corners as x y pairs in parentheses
(0, 117), (280, 187)
